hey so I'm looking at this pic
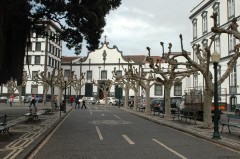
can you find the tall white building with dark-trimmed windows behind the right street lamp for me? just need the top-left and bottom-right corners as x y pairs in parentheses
(189, 0), (240, 111)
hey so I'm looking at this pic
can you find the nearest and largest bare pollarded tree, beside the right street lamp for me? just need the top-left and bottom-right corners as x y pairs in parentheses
(180, 13), (240, 128)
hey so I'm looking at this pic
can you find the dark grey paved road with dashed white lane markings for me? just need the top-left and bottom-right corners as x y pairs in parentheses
(29, 106), (240, 159)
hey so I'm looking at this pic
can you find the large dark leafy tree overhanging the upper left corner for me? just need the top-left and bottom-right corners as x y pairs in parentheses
(0, 0), (121, 84)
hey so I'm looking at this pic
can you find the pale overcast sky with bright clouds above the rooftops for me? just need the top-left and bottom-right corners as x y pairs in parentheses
(63, 0), (202, 56)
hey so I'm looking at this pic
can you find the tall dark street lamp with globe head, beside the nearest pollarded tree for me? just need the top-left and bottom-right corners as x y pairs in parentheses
(211, 51), (221, 139)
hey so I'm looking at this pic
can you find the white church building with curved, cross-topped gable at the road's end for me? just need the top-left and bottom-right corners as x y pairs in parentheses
(61, 40), (191, 99)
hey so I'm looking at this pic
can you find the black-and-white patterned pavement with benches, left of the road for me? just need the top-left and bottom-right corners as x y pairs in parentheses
(0, 103), (72, 159)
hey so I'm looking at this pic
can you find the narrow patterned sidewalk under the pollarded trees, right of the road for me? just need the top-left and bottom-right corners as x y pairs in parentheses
(123, 108), (240, 151)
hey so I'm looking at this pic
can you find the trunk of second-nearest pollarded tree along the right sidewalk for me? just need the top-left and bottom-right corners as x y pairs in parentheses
(164, 84), (171, 119)
